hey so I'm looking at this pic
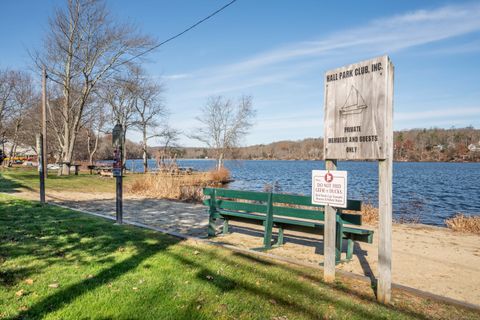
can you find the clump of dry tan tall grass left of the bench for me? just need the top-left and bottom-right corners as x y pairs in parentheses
(127, 168), (230, 202)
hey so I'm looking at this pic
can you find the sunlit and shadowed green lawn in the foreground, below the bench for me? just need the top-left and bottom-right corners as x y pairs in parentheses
(0, 195), (480, 320)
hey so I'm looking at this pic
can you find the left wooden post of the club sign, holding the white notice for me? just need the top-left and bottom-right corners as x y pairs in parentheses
(323, 160), (337, 282)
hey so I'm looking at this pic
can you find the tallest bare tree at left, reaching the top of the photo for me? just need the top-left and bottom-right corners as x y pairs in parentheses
(34, 0), (152, 174)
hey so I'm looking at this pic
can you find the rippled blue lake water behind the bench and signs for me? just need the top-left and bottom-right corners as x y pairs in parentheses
(127, 159), (480, 225)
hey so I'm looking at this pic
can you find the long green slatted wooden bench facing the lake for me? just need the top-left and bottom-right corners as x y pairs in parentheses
(203, 188), (373, 263)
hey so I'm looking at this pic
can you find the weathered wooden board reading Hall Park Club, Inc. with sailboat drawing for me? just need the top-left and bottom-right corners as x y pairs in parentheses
(324, 56), (393, 160)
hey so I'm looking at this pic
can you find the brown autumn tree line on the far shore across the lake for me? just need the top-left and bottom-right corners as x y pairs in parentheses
(180, 127), (480, 162)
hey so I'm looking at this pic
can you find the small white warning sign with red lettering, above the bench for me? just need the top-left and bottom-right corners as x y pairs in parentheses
(312, 170), (347, 208)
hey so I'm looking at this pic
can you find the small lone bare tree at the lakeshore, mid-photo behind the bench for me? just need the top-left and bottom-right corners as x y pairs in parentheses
(190, 96), (256, 169)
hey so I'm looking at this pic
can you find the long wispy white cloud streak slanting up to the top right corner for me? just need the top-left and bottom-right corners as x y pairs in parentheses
(175, 3), (480, 91)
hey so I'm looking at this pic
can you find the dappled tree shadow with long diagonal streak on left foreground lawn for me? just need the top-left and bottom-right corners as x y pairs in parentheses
(0, 200), (184, 319)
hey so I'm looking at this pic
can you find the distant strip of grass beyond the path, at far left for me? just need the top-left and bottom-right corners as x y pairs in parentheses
(0, 167), (137, 193)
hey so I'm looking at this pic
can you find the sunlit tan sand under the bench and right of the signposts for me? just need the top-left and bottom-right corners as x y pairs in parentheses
(211, 220), (480, 304)
